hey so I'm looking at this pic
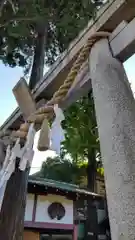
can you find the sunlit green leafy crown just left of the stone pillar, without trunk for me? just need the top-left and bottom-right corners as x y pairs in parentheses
(63, 93), (99, 161)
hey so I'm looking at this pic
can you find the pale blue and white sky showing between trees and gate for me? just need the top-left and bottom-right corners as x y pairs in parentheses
(0, 55), (135, 174)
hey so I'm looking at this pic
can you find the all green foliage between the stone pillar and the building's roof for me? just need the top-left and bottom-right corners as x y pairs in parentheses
(32, 93), (103, 190)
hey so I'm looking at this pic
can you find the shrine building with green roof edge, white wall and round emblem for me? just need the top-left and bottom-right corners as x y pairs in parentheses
(24, 177), (106, 240)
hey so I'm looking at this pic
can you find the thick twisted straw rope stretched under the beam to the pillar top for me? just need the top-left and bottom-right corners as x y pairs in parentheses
(1, 32), (110, 143)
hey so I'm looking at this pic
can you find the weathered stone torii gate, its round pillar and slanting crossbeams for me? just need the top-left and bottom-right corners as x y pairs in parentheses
(0, 0), (135, 240)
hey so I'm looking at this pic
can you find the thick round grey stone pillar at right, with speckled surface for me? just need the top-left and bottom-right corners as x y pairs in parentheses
(89, 39), (135, 240)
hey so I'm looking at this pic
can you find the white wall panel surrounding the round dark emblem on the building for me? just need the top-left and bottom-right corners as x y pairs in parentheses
(35, 194), (73, 224)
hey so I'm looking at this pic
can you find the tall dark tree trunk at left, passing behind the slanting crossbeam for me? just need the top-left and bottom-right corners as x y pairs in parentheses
(0, 23), (46, 240)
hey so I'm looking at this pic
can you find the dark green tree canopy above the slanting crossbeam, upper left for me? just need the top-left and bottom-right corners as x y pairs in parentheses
(0, 0), (102, 70)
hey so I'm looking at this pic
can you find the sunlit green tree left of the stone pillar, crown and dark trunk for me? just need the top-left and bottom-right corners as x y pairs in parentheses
(62, 92), (103, 191)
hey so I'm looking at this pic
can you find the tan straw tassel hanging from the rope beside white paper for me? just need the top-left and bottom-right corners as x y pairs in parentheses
(37, 118), (50, 151)
